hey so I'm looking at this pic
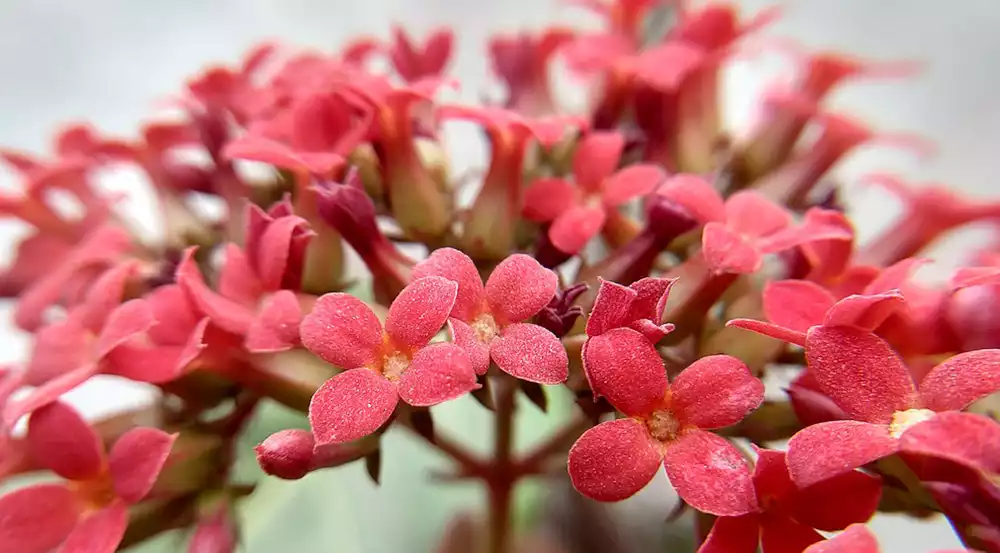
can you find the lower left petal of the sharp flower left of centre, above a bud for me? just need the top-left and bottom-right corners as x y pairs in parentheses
(309, 369), (399, 445)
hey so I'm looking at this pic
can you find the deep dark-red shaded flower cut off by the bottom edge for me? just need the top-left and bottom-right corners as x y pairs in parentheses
(698, 450), (882, 553)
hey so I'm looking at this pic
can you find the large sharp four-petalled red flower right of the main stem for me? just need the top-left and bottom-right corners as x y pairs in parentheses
(569, 328), (764, 516)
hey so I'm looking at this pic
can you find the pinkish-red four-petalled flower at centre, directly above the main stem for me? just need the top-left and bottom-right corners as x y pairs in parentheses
(413, 248), (569, 384)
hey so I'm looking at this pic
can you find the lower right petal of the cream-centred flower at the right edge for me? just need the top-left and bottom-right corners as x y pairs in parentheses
(899, 412), (1000, 474)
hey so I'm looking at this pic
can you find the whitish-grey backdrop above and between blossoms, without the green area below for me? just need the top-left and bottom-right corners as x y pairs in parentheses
(0, 0), (1000, 553)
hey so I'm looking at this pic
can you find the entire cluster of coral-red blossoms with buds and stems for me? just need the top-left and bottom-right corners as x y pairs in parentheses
(0, 0), (1000, 553)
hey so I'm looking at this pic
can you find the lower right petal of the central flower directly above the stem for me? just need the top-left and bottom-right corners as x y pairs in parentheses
(490, 323), (569, 384)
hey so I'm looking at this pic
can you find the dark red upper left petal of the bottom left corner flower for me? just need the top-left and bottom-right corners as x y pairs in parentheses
(28, 401), (104, 480)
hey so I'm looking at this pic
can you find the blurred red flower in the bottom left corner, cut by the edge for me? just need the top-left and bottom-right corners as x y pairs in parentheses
(0, 403), (176, 553)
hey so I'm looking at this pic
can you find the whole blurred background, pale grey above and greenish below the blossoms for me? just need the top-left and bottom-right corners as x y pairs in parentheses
(0, 0), (1000, 553)
